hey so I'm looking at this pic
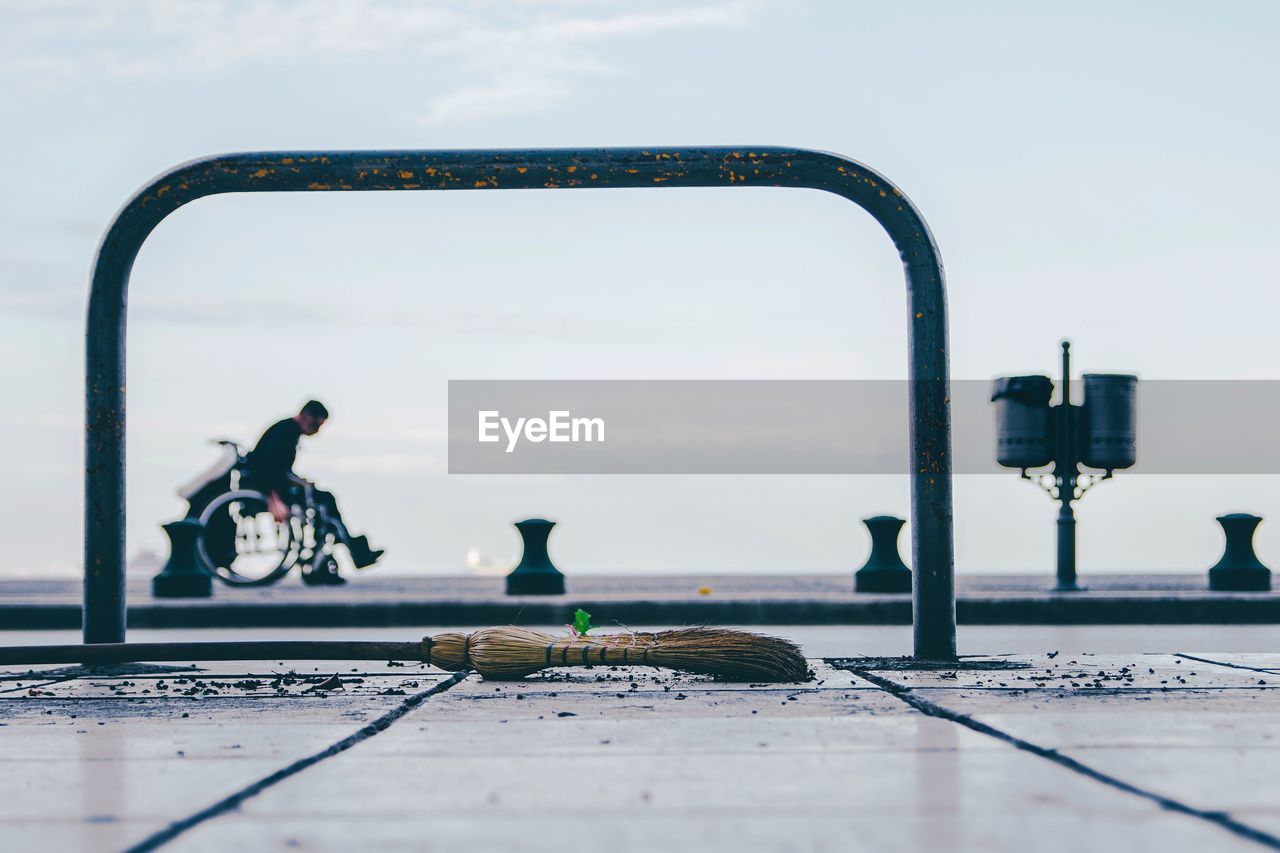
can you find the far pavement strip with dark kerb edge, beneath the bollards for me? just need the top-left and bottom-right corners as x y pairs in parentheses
(0, 573), (1280, 629)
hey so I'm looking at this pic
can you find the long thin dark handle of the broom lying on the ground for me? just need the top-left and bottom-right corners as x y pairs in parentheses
(0, 640), (422, 666)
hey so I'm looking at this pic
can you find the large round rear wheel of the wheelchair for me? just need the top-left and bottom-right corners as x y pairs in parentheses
(196, 489), (303, 587)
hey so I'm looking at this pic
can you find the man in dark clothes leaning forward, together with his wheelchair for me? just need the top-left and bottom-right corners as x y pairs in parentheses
(184, 400), (383, 585)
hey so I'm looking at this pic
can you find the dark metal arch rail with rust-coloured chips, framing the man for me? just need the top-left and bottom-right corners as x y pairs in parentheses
(83, 146), (956, 660)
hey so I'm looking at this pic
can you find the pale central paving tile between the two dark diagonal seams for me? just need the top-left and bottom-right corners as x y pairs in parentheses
(192, 681), (1249, 850)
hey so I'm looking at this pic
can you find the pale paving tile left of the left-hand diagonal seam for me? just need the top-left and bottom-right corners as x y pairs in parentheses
(0, 675), (445, 850)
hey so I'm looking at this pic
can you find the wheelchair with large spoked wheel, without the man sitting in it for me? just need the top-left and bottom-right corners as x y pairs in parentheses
(179, 439), (338, 587)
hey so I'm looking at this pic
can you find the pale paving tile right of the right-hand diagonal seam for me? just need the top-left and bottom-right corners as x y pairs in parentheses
(829, 656), (1280, 829)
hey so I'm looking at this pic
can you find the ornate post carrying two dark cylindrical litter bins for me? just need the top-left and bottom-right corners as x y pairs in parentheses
(991, 341), (1138, 592)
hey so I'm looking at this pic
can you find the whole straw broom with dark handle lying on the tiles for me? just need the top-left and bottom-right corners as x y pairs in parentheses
(0, 626), (809, 681)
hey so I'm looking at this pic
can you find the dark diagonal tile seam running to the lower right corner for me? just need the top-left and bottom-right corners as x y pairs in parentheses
(849, 667), (1280, 850)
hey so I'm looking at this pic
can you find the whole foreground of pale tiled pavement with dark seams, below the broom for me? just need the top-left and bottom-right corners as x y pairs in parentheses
(0, 637), (1280, 852)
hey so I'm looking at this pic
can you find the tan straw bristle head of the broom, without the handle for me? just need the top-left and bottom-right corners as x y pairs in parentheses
(422, 626), (809, 681)
